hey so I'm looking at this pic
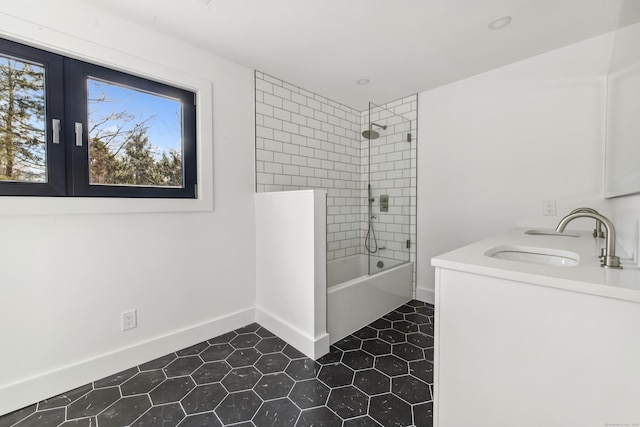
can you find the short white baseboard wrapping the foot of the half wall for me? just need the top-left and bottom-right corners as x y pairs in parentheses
(256, 307), (329, 360)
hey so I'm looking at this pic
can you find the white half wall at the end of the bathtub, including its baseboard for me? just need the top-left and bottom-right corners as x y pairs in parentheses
(255, 190), (329, 359)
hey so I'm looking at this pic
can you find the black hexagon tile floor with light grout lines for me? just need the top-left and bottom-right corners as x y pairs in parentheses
(0, 301), (433, 427)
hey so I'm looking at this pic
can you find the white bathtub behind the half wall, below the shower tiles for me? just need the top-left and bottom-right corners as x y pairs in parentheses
(327, 255), (413, 344)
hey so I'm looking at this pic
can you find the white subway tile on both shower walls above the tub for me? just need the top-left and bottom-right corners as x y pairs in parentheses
(255, 72), (417, 290)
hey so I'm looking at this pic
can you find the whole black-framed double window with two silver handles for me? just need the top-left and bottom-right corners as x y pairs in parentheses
(0, 40), (197, 198)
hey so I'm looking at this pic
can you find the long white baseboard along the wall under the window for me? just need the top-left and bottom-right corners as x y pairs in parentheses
(0, 308), (255, 415)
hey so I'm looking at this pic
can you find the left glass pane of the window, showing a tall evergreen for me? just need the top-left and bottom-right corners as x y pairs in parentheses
(0, 55), (47, 182)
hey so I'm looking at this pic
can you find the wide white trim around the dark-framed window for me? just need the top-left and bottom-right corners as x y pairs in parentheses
(0, 14), (213, 216)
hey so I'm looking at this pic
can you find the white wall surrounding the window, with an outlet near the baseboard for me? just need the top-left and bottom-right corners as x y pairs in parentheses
(0, 0), (255, 414)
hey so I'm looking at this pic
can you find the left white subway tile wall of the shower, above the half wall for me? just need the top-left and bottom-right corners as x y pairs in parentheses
(255, 72), (362, 260)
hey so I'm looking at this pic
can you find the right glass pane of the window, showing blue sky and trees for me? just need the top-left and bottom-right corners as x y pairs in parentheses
(87, 78), (183, 187)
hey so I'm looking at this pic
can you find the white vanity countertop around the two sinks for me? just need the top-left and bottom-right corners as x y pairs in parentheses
(431, 228), (640, 302)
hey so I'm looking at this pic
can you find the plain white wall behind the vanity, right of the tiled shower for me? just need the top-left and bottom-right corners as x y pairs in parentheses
(418, 35), (612, 301)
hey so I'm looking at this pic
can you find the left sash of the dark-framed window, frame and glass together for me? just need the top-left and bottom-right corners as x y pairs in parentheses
(0, 40), (65, 196)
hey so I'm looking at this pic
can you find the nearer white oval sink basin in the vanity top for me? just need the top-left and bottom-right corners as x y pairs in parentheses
(485, 246), (580, 267)
